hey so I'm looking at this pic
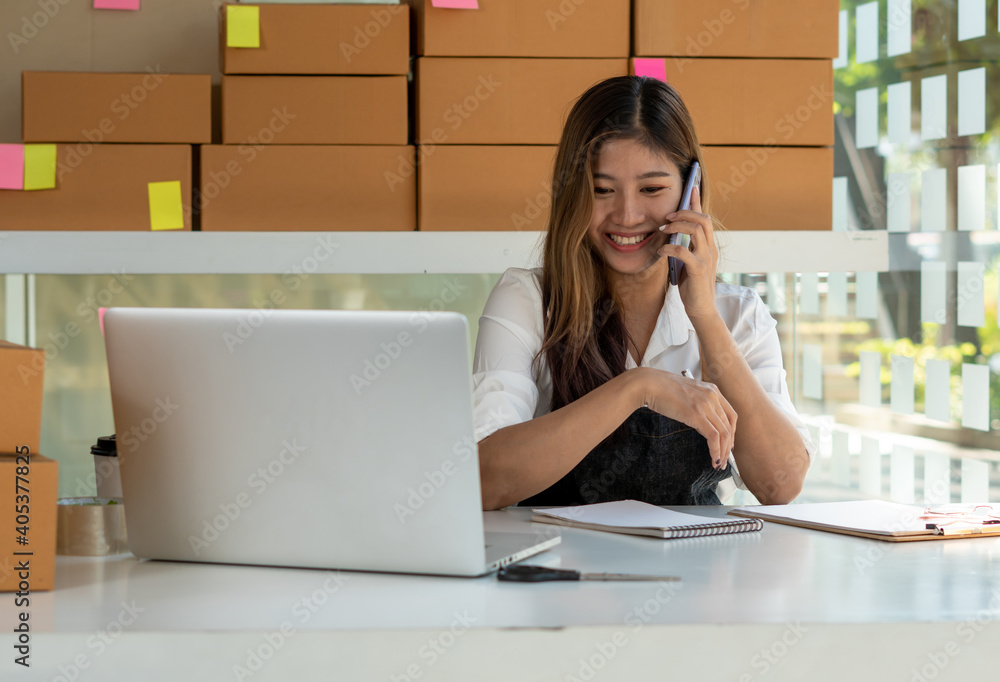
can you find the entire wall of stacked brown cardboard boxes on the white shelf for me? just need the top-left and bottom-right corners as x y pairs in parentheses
(0, 0), (838, 230)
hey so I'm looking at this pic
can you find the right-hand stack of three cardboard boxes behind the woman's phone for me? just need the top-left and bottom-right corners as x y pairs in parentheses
(632, 0), (839, 230)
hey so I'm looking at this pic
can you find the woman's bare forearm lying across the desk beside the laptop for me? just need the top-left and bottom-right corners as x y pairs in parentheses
(479, 371), (642, 510)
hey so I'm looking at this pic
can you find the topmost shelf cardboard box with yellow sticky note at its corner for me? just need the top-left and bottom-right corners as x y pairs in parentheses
(219, 5), (410, 76)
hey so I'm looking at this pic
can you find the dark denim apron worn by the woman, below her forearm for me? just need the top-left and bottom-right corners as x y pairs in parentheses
(519, 407), (733, 507)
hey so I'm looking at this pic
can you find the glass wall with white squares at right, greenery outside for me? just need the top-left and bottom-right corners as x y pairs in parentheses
(789, 0), (1000, 504)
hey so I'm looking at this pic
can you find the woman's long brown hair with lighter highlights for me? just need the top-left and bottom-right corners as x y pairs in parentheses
(535, 76), (708, 446)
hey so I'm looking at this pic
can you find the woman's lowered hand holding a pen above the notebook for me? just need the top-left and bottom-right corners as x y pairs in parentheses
(630, 367), (736, 469)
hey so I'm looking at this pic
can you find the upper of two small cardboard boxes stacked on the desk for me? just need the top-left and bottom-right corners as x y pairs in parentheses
(0, 341), (45, 454)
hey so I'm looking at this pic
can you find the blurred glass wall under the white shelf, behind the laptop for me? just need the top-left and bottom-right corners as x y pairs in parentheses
(25, 275), (499, 497)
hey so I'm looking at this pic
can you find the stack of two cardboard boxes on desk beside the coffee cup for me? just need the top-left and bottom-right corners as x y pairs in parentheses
(0, 341), (59, 588)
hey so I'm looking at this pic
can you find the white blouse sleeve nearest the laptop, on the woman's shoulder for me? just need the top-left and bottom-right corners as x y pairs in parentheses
(472, 268), (542, 442)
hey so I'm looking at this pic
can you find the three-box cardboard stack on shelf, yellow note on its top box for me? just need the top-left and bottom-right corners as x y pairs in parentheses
(205, 4), (416, 231)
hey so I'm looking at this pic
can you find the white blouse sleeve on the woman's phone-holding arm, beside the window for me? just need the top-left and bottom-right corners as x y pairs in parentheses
(733, 291), (816, 489)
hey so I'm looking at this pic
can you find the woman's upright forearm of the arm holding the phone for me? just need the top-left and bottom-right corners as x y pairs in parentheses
(692, 316), (809, 504)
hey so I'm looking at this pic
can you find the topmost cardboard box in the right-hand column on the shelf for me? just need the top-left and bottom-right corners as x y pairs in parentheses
(632, 0), (840, 59)
